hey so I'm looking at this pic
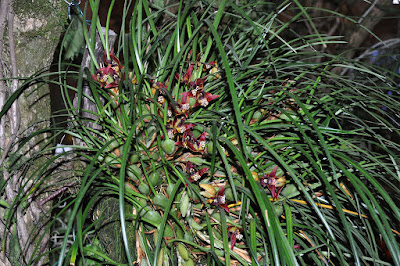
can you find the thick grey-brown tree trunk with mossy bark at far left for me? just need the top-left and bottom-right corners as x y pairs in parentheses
(0, 0), (67, 265)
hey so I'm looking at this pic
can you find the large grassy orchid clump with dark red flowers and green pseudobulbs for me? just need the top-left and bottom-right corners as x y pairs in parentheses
(35, 1), (400, 265)
